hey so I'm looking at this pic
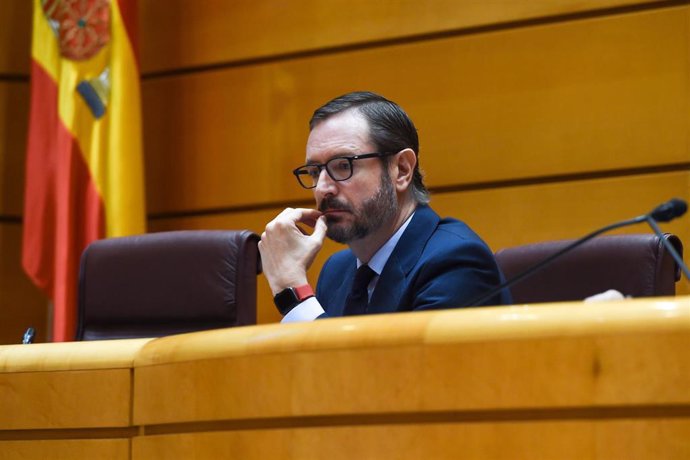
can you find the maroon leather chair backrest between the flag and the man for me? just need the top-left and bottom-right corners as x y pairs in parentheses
(76, 230), (261, 340)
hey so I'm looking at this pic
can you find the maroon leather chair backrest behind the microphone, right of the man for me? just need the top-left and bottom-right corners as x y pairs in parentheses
(496, 234), (683, 304)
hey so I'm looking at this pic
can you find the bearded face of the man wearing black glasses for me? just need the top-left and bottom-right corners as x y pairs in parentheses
(307, 110), (398, 243)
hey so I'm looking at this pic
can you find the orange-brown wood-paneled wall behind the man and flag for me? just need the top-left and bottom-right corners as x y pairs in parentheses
(0, 0), (690, 341)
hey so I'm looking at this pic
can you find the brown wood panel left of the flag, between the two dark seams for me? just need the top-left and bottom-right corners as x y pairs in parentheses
(0, 81), (29, 216)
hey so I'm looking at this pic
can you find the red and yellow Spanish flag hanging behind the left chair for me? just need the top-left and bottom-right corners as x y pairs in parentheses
(22, 0), (146, 341)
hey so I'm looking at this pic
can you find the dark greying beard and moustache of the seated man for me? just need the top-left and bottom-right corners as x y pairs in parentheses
(319, 170), (398, 244)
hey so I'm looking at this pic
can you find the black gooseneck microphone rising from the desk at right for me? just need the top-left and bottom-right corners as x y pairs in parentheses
(462, 198), (690, 307)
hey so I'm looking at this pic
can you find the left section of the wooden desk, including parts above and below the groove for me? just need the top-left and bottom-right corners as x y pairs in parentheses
(0, 339), (150, 460)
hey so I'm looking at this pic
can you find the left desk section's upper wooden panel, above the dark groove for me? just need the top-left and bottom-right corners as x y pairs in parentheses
(0, 339), (150, 432)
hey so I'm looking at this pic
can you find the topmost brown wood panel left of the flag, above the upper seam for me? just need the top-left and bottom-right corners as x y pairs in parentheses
(0, 0), (32, 76)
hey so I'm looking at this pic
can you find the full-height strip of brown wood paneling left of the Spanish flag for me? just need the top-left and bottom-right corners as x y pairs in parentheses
(0, 4), (34, 348)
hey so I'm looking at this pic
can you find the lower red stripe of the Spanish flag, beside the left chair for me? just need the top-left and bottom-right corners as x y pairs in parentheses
(22, 62), (105, 341)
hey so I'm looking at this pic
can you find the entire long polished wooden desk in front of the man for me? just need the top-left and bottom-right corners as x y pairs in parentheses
(0, 297), (690, 459)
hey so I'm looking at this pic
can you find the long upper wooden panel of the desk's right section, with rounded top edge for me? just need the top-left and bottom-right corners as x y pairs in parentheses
(134, 300), (690, 429)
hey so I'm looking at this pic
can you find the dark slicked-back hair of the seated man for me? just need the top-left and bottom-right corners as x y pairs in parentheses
(309, 91), (429, 204)
